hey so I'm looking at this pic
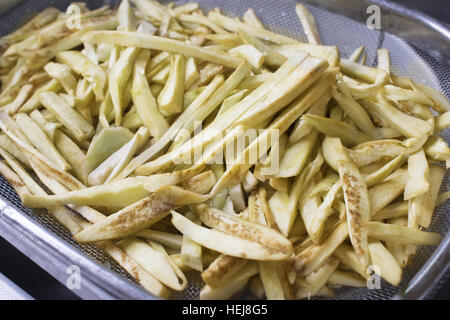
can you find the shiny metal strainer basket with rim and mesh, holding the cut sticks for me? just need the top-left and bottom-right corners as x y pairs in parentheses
(0, 0), (450, 299)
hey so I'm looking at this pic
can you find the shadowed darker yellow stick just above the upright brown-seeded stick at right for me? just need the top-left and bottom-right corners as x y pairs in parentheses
(302, 114), (370, 146)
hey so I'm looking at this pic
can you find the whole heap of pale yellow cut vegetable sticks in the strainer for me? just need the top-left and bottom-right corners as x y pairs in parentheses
(0, 0), (450, 299)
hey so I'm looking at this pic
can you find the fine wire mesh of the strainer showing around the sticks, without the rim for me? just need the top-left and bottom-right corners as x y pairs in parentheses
(0, 0), (450, 299)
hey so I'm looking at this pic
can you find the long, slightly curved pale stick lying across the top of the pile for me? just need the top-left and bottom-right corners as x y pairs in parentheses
(82, 31), (242, 68)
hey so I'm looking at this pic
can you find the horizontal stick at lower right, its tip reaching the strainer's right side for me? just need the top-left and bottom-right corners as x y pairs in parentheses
(367, 222), (441, 246)
